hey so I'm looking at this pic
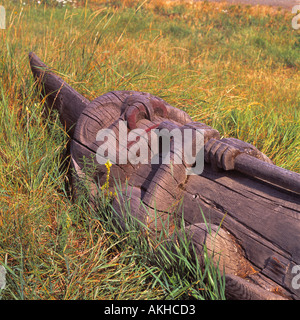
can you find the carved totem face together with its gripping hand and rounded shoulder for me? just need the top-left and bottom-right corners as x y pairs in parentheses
(71, 91), (274, 235)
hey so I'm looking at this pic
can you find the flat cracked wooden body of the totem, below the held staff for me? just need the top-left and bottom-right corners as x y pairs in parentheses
(184, 167), (300, 297)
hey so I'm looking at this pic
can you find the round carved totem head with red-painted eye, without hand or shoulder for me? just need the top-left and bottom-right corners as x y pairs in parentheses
(71, 91), (220, 182)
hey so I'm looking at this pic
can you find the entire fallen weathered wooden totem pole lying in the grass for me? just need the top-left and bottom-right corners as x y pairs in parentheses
(29, 53), (300, 300)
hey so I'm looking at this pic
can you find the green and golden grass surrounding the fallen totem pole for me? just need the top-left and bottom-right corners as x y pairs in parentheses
(0, 0), (300, 299)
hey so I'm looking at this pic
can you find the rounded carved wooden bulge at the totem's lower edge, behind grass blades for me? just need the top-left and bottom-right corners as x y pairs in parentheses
(186, 223), (287, 300)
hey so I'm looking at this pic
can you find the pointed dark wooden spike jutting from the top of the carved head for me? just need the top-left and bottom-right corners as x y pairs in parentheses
(29, 52), (90, 137)
